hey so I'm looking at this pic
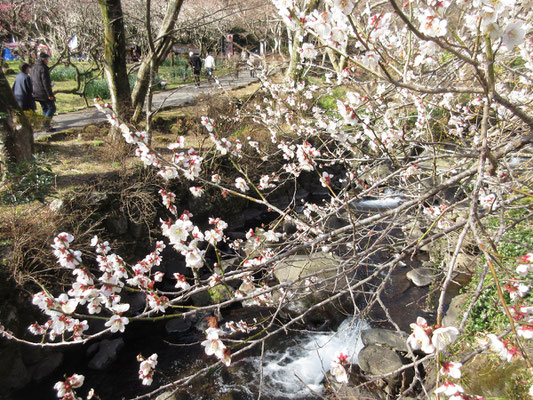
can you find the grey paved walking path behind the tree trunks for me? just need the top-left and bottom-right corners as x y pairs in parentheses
(34, 70), (257, 138)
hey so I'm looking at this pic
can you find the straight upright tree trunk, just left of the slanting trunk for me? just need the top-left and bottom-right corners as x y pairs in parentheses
(98, 0), (131, 120)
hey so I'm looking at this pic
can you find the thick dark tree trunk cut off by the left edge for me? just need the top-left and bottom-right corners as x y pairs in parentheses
(0, 68), (33, 171)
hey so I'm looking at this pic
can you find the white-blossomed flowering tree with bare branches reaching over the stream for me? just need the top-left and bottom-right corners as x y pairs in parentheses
(4, 0), (533, 400)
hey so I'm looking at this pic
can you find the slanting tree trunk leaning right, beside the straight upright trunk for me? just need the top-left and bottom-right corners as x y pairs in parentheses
(131, 0), (183, 120)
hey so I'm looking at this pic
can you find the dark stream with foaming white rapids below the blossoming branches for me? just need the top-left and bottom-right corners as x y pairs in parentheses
(7, 197), (448, 400)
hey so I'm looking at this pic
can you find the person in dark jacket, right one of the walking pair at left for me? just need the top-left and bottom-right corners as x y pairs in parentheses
(30, 53), (56, 132)
